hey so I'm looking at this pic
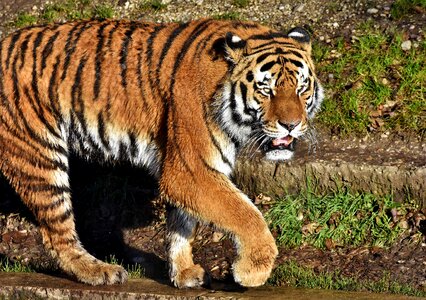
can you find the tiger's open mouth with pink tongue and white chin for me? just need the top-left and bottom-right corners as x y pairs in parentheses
(263, 135), (297, 160)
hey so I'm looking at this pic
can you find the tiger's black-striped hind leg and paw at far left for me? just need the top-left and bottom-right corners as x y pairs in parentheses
(0, 134), (127, 285)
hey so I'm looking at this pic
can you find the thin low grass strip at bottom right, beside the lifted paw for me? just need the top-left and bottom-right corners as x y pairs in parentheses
(268, 261), (426, 297)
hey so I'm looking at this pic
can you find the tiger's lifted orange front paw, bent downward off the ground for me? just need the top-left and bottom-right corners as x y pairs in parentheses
(233, 237), (278, 287)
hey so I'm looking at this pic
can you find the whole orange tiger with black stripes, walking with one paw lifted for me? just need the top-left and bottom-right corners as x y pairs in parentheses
(0, 19), (324, 288)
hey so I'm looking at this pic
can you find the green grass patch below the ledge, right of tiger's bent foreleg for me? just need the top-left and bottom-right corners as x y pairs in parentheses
(266, 191), (407, 248)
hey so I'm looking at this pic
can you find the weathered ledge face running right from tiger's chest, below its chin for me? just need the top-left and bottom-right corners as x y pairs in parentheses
(235, 159), (426, 207)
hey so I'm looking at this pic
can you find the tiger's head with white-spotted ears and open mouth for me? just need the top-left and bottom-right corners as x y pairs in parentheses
(216, 28), (323, 160)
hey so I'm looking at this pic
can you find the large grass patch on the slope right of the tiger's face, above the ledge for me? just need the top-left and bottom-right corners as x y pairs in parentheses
(313, 24), (426, 136)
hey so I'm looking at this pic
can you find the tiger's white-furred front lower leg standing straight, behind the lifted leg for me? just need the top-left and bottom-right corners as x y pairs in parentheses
(167, 208), (210, 288)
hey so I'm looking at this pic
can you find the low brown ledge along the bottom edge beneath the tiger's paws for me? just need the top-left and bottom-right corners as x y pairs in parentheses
(0, 273), (421, 300)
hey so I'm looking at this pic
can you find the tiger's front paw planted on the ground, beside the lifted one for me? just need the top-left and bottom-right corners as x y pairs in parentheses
(171, 264), (210, 289)
